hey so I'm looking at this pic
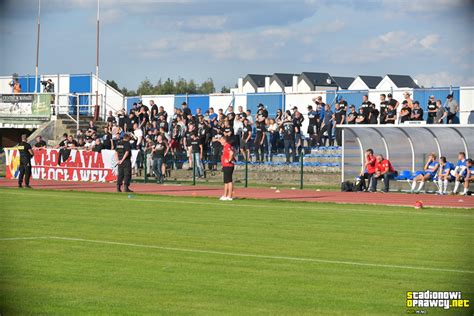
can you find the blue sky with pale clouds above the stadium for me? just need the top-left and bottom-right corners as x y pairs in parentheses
(0, 0), (474, 89)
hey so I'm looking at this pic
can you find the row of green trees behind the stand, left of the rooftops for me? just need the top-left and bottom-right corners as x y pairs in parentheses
(107, 78), (230, 96)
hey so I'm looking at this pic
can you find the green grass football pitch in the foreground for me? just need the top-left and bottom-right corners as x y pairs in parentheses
(0, 188), (474, 315)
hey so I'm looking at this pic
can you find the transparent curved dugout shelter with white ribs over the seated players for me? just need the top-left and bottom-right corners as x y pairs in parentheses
(339, 124), (474, 190)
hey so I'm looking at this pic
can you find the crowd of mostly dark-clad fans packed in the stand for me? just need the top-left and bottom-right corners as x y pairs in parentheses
(32, 92), (459, 182)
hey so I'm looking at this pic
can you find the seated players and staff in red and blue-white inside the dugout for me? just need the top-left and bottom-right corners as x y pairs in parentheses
(356, 149), (474, 195)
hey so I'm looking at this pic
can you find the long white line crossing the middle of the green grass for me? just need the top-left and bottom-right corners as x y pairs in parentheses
(0, 236), (474, 274)
